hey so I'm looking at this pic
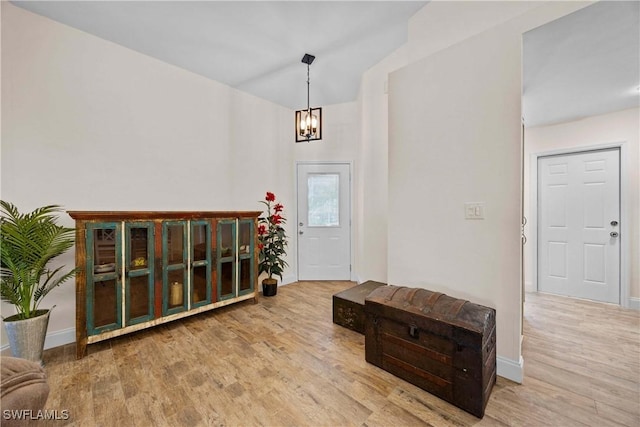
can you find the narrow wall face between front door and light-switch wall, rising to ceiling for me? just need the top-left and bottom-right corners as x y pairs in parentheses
(357, 1), (587, 288)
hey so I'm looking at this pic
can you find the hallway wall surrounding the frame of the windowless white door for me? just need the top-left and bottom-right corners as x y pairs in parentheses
(524, 108), (640, 308)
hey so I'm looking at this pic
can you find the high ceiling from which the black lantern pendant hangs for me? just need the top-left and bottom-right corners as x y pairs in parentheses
(12, 1), (427, 109)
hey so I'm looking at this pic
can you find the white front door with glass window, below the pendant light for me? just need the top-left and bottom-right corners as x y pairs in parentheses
(297, 163), (351, 280)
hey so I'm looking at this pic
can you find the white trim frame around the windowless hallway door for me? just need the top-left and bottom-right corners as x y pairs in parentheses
(529, 141), (631, 308)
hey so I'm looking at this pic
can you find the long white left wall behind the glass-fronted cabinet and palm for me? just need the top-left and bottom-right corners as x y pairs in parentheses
(1, 2), (288, 345)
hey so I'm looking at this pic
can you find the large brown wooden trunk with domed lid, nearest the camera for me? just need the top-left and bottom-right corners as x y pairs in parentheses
(365, 286), (496, 418)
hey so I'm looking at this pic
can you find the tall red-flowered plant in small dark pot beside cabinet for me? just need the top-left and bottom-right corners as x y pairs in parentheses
(258, 191), (288, 297)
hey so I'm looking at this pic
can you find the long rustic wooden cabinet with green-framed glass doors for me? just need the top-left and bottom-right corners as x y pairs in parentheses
(69, 211), (260, 358)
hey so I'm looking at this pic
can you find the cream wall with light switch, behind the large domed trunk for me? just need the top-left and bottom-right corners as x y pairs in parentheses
(388, 2), (586, 381)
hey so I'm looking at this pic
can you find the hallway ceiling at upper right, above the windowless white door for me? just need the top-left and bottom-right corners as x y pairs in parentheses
(522, 1), (640, 127)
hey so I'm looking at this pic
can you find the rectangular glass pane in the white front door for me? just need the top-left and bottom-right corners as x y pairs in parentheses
(307, 174), (340, 227)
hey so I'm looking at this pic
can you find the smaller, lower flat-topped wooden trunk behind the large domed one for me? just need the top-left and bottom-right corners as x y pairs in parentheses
(333, 280), (385, 334)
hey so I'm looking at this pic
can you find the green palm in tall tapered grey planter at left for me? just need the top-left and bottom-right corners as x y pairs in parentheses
(0, 200), (76, 364)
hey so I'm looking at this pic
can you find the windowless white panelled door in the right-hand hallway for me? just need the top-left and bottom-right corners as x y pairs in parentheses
(538, 149), (621, 303)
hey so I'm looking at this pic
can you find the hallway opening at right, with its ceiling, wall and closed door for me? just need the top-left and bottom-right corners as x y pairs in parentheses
(522, 2), (640, 308)
